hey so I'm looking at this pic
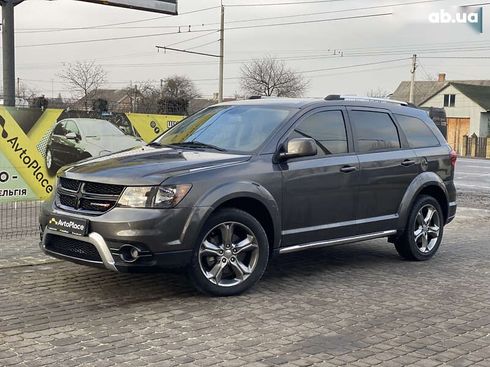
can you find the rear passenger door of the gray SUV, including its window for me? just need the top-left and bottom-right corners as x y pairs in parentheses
(348, 107), (420, 233)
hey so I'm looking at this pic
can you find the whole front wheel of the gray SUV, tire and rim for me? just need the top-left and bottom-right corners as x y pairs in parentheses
(188, 208), (269, 296)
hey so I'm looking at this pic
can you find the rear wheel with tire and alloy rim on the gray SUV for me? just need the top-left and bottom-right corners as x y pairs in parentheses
(395, 195), (444, 261)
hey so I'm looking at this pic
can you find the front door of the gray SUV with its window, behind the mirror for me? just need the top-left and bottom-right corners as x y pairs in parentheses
(281, 108), (359, 246)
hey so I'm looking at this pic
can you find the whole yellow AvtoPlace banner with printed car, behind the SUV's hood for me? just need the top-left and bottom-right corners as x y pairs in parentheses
(0, 107), (183, 202)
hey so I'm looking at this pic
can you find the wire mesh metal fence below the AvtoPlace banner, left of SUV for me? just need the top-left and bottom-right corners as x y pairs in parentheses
(0, 201), (41, 240)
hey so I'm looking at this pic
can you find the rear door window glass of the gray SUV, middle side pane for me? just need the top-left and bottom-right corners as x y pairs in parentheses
(349, 111), (400, 153)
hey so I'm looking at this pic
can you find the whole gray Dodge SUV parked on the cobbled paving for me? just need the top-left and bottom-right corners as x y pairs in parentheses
(40, 95), (456, 296)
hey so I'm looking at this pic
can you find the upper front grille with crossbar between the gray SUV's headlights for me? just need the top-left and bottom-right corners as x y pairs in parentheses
(56, 177), (124, 215)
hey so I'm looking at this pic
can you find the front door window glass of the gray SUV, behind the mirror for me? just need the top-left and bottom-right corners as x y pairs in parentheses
(290, 111), (348, 155)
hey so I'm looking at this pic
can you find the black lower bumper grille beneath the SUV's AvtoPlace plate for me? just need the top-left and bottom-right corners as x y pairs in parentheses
(45, 234), (102, 262)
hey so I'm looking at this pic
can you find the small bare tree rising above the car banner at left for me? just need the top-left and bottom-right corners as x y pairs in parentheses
(59, 61), (107, 110)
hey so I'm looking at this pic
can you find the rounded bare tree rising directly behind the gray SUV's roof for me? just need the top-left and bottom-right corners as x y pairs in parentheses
(240, 57), (309, 97)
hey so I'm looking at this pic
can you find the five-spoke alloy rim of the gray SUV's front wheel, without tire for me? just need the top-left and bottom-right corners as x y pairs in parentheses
(199, 222), (259, 287)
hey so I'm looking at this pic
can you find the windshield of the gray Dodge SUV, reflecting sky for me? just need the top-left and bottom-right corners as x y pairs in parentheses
(155, 106), (291, 153)
